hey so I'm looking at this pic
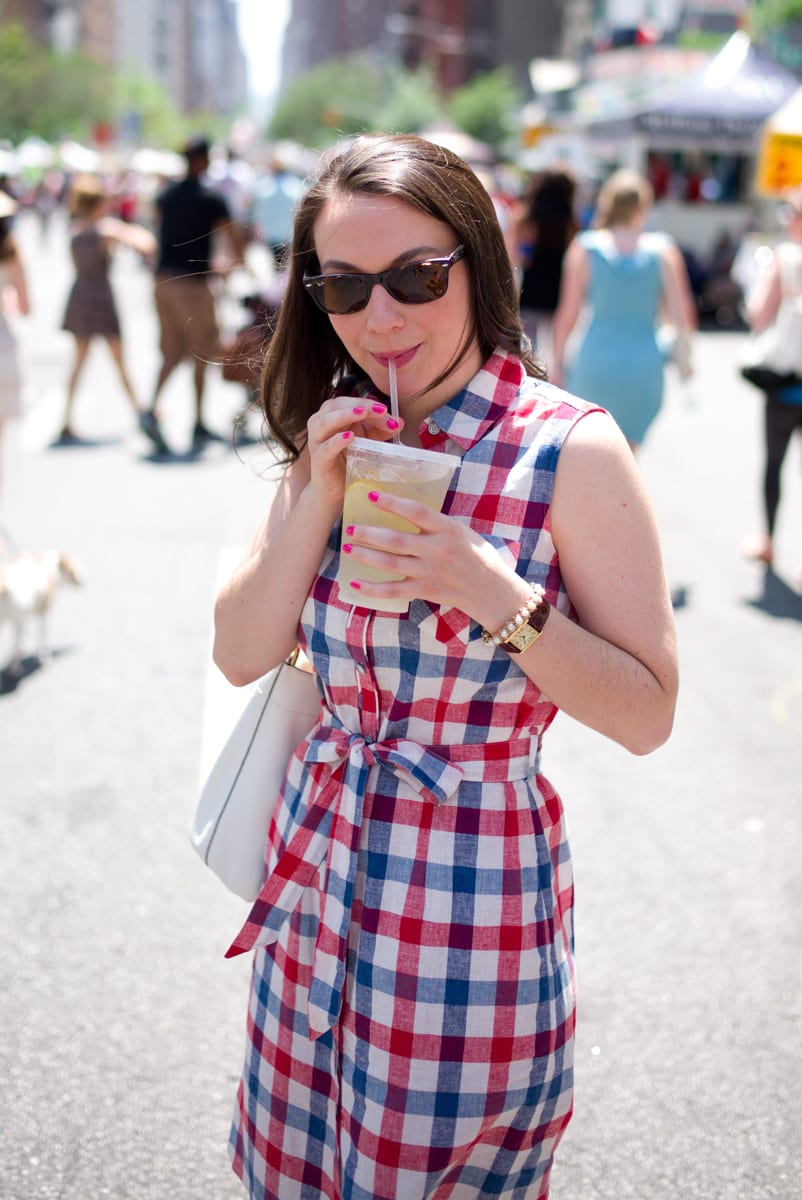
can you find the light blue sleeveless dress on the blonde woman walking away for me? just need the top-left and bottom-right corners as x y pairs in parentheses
(565, 230), (669, 445)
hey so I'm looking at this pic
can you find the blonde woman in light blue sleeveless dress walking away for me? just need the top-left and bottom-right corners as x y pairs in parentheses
(550, 169), (696, 450)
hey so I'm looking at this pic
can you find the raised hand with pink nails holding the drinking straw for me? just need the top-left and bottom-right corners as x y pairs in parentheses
(306, 396), (403, 511)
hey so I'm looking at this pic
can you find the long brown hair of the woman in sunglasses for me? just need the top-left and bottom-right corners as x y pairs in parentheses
(262, 134), (545, 460)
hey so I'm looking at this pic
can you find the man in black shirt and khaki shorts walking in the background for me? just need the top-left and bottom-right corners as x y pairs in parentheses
(142, 138), (243, 454)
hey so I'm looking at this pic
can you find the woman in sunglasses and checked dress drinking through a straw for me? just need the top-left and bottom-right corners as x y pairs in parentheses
(215, 136), (676, 1200)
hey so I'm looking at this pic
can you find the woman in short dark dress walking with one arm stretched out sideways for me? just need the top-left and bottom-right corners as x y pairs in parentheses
(56, 175), (156, 445)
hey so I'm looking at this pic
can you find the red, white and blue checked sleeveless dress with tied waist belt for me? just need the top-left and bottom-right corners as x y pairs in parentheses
(228, 353), (600, 1200)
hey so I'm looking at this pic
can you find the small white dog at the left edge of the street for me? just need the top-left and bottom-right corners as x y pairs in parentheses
(0, 550), (86, 672)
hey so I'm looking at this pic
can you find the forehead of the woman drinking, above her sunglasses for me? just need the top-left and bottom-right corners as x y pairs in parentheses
(315, 192), (454, 270)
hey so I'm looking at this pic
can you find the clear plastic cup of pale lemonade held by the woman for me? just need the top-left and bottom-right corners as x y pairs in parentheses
(337, 438), (461, 612)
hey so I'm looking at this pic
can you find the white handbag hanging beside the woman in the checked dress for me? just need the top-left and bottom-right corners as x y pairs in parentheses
(190, 650), (321, 901)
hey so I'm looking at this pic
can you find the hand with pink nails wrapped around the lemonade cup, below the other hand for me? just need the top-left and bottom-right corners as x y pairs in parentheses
(343, 485), (516, 628)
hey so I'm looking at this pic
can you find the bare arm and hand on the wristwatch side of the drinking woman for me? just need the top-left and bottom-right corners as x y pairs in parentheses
(343, 413), (677, 755)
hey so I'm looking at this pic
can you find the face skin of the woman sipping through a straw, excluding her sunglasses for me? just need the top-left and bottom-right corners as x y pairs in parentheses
(315, 194), (481, 426)
